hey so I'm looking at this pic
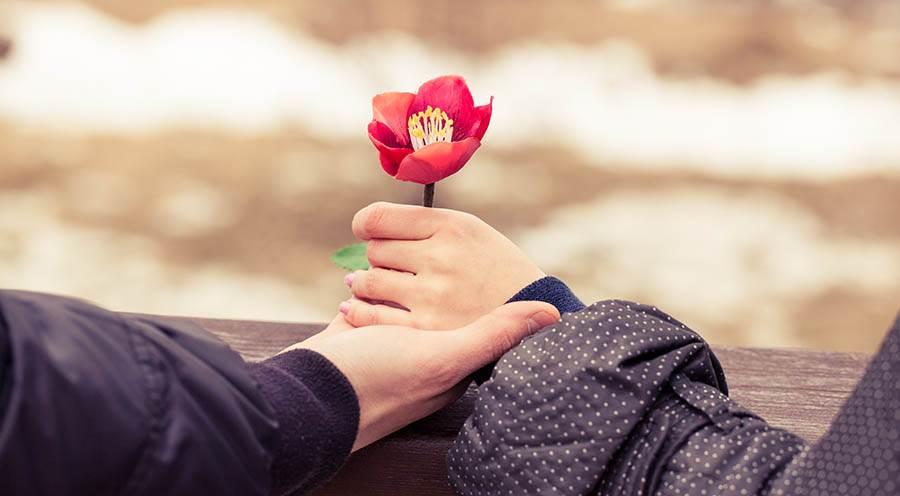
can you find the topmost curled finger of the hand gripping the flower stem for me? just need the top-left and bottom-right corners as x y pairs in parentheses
(352, 202), (446, 241)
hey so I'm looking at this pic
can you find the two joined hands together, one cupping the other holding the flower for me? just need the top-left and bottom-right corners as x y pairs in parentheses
(285, 203), (559, 450)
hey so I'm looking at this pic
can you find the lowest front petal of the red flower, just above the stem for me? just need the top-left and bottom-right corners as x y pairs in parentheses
(394, 138), (481, 184)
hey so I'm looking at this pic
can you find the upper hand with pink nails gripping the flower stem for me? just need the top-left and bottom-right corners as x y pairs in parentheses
(341, 202), (545, 329)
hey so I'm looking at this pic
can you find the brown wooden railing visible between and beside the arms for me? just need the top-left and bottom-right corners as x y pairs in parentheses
(171, 319), (869, 495)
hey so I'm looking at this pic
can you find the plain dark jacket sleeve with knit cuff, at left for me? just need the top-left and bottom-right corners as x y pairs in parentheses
(0, 291), (358, 496)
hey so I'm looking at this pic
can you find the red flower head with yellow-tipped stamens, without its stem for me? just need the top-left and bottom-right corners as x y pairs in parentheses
(369, 72), (494, 184)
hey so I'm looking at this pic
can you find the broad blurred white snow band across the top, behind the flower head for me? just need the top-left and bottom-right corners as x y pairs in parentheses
(0, 2), (900, 179)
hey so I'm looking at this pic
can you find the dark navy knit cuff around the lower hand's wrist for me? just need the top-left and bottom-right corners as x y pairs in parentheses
(249, 349), (359, 494)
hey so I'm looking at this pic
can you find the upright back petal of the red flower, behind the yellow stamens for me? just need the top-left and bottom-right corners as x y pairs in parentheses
(408, 76), (476, 141)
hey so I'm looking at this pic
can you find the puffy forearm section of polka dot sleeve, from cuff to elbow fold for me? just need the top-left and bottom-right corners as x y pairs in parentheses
(448, 301), (725, 495)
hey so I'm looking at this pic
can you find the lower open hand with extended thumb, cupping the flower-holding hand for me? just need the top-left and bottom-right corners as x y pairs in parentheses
(285, 301), (559, 451)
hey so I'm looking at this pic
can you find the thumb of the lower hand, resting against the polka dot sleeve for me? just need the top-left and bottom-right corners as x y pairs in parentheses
(459, 301), (559, 372)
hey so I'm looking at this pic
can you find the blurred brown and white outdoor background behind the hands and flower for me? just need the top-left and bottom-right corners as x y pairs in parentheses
(0, 0), (900, 351)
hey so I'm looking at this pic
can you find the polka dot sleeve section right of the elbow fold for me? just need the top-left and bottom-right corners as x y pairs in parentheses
(600, 392), (804, 496)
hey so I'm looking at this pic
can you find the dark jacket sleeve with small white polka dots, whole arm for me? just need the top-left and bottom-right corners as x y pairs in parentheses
(448, 301), (803, 496)
